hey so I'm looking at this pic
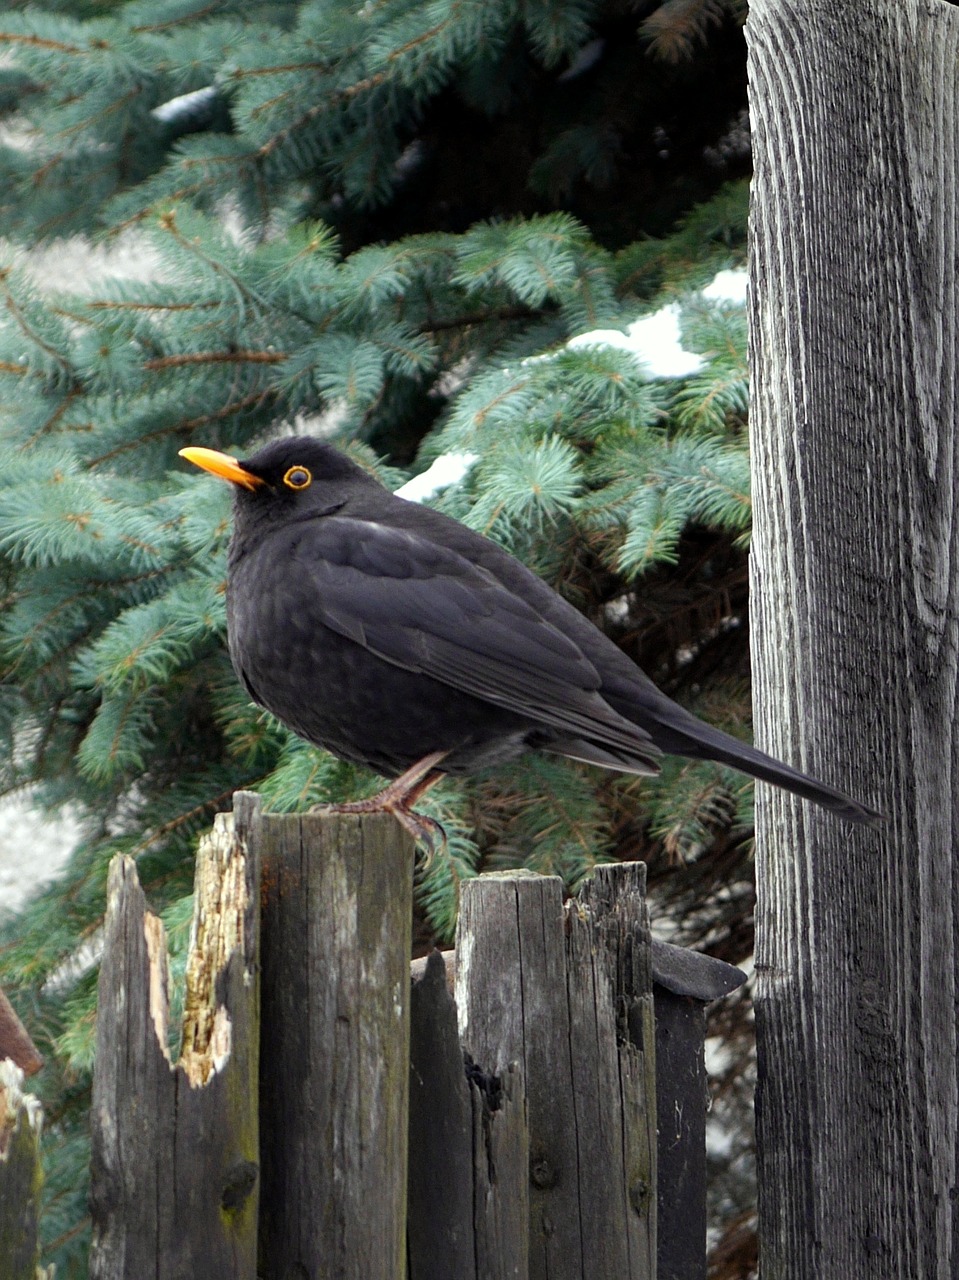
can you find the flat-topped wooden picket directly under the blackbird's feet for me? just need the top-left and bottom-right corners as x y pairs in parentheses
(259, 813), (414, 1280)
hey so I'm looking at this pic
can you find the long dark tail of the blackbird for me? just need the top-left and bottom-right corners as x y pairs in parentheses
(643, 699), (886, 827)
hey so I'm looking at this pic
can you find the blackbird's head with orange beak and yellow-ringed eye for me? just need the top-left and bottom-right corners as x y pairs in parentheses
(179, 435), (378, 527)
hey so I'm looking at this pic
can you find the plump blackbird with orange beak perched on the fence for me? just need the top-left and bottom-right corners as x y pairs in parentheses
(181, 436), (880, 836)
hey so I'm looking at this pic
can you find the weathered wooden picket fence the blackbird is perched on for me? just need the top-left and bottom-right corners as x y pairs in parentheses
(0, 794), (741, 1280)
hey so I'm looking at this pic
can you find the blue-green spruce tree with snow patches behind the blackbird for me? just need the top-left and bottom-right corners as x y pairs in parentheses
(0, 0), (752, 1276)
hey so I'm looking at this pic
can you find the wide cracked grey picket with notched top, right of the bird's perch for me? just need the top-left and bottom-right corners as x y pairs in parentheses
(456, 863), (656, 1280)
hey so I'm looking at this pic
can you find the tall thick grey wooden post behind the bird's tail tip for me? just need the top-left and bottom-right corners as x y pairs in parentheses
(748, 0), (959, 1280)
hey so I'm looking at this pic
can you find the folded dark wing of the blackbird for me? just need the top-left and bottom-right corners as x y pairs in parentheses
(288, 516), (659, 772)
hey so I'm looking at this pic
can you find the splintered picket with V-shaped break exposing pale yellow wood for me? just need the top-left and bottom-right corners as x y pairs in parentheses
(90, 801), (260, 1280)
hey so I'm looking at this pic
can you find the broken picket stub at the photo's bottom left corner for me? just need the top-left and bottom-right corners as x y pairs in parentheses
(0, 1059), (42, 1280)
